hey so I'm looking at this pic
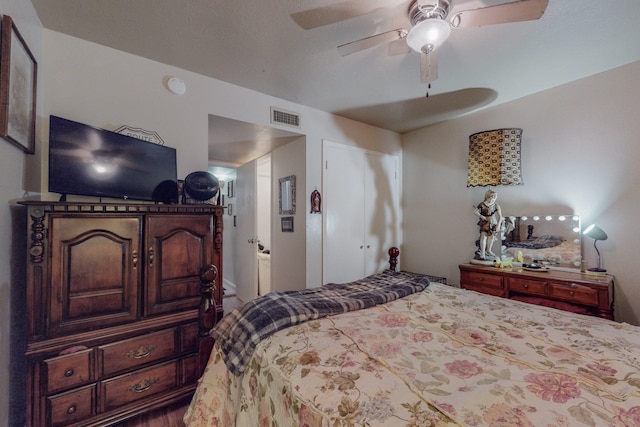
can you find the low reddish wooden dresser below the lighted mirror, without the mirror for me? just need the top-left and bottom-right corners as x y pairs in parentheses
(460, 264), (613, 320)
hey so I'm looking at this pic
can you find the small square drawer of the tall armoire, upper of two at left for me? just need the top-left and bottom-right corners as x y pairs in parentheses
(44, 349), (92, 393)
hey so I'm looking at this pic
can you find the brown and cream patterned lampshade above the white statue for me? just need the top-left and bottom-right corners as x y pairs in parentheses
(467, 128), (522, 187)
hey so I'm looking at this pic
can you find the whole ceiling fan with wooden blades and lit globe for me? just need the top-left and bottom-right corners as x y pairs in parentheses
(292, 0), (549, 83)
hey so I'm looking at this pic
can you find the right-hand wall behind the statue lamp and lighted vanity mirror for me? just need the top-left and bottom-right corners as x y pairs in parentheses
(401, 62), (640, 324)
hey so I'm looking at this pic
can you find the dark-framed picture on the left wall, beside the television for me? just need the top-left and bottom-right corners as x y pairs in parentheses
(0, 15), (38, 154)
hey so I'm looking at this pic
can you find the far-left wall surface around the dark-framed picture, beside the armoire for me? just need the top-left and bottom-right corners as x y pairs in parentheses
(0, 0), (42, 427)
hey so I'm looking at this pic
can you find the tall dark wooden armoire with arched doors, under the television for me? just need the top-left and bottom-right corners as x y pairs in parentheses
(19, 201), (223, 427)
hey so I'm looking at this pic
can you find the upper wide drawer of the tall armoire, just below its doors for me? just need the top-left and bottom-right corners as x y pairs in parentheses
(98, 329), (176, 376)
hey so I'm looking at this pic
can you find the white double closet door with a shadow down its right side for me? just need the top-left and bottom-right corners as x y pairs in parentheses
(323, 141), (399, 283)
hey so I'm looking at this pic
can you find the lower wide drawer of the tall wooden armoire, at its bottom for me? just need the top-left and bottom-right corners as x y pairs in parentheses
(100, 360), (177, 411)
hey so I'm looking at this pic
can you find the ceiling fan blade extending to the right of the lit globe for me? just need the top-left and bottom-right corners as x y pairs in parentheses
(451, 0), (549, 28)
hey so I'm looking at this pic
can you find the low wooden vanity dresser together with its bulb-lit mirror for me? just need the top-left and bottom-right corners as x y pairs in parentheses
(459, 215), (614, 319)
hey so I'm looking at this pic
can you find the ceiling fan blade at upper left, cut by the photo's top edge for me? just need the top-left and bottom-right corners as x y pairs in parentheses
(291, 0), (402, 30)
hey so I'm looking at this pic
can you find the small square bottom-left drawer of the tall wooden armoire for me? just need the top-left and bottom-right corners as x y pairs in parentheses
(47, 384), (96, 427)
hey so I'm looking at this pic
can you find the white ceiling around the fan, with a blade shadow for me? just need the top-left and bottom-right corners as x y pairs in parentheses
(32, 0), (640, 164)
